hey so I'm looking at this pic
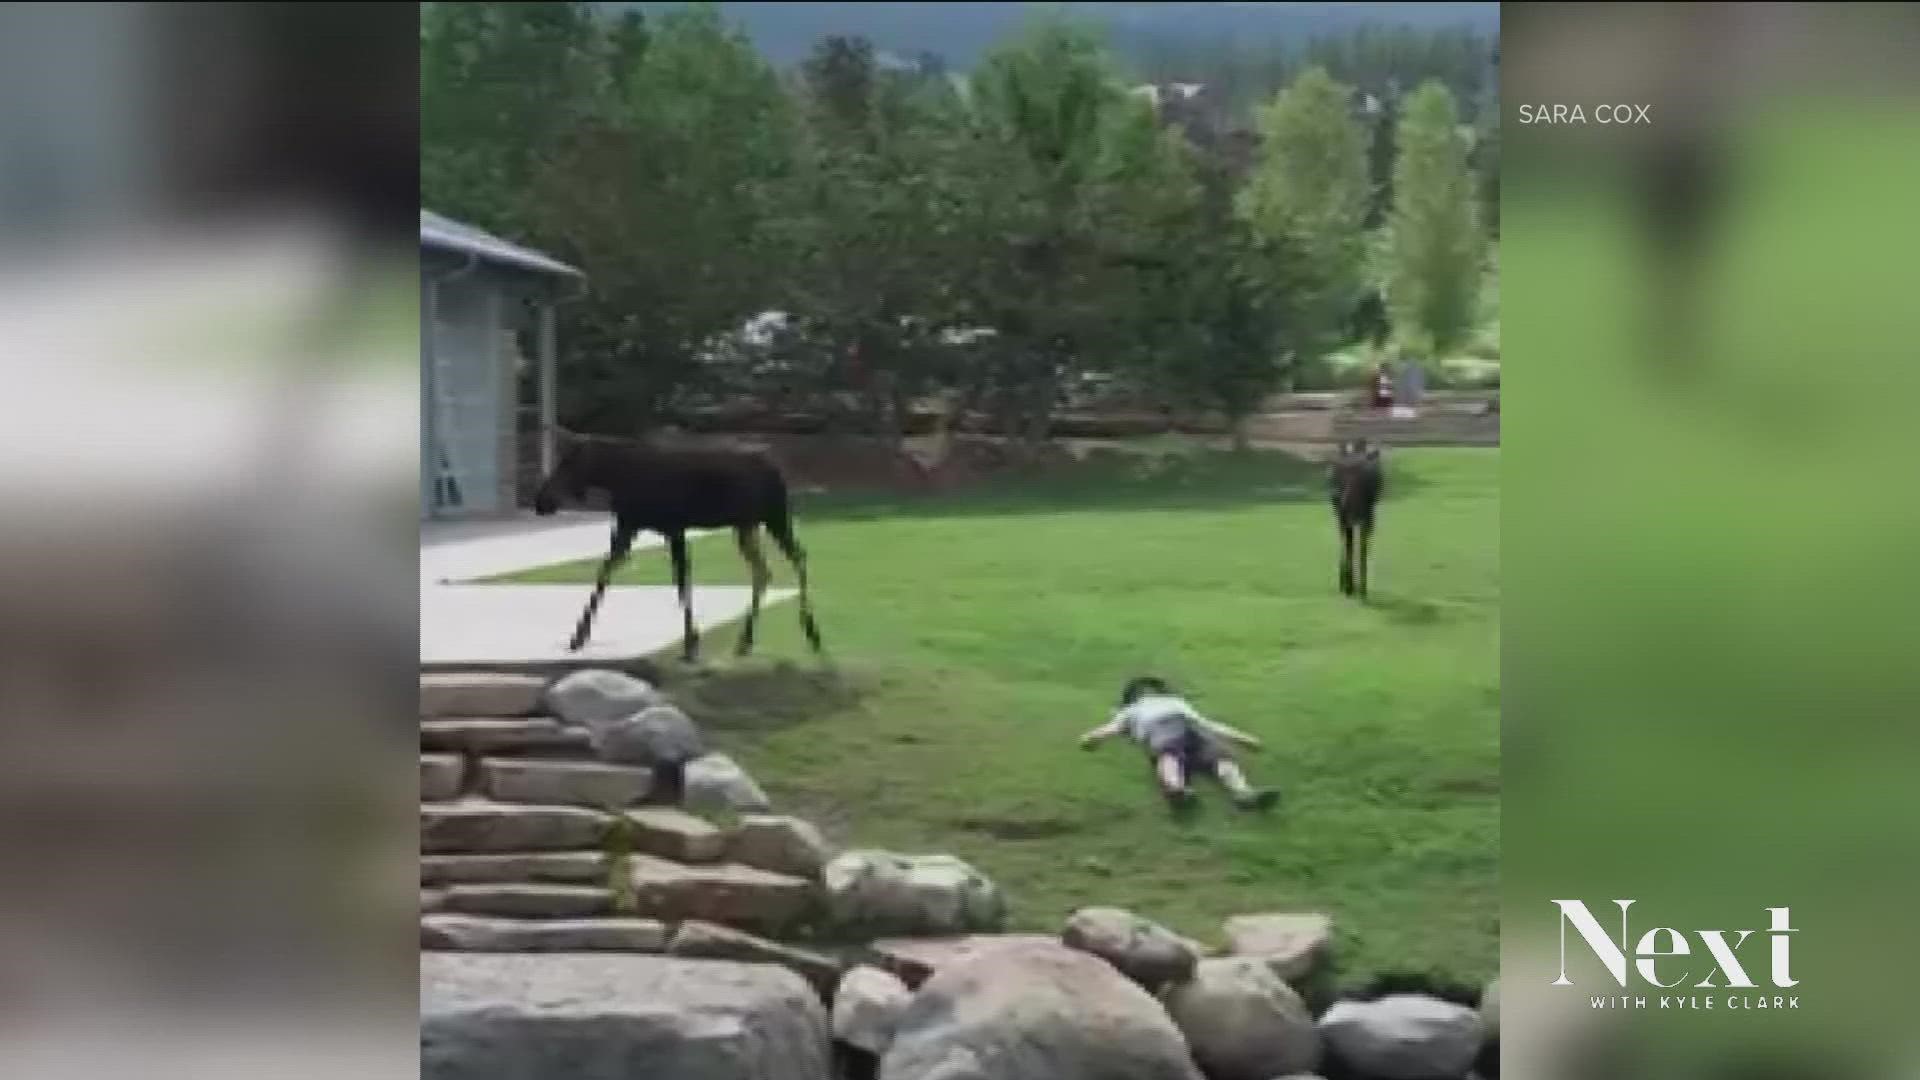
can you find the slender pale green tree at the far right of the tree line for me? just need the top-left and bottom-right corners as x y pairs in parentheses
(1386, 83), (1484, 357)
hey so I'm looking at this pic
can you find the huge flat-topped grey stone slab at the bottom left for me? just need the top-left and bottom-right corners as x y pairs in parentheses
(420, 953), (829, 1080)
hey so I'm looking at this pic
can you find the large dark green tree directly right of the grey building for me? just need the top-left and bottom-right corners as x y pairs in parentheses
(526, 6), (793, 432)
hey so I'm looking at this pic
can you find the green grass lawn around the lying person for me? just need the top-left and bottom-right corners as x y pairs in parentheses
(516, 438), (1500, 980)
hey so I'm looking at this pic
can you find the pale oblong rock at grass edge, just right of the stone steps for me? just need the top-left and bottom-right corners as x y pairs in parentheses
(822, 851), (1006, 934)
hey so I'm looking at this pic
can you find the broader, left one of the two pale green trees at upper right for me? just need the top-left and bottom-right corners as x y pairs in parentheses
(1238, 67), (1371, 380)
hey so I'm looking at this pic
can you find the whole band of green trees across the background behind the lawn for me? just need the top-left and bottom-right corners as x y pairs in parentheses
(420, 2), (1498, 440)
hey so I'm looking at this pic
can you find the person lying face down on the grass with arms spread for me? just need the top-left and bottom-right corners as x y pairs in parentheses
(1081, 675), (1281, 809)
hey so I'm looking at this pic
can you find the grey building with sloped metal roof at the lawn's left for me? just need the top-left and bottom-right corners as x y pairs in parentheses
(420, 209), (586, 521)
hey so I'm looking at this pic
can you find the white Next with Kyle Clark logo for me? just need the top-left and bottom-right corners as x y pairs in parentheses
(1553, 899), (1799, 1011)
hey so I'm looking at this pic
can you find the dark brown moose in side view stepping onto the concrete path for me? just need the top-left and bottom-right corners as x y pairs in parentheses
(534, 438), (822, 663)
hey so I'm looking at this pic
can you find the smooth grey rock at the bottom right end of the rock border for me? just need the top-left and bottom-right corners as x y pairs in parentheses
(1319, 994), (1486, 1080)
